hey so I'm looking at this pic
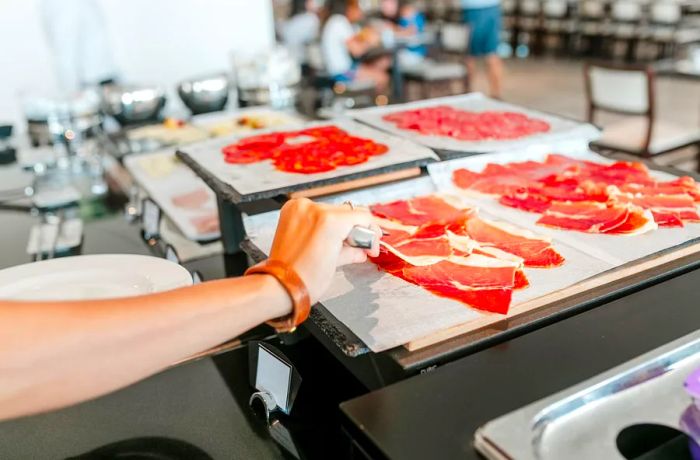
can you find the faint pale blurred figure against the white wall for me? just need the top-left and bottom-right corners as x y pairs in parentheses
(40, 0), (117, 93)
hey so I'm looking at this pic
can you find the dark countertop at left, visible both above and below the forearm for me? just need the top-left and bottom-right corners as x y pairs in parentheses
(0, 211), (282, 460)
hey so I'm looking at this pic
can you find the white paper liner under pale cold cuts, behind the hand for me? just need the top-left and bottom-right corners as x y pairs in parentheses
(124, 147), (221, 241)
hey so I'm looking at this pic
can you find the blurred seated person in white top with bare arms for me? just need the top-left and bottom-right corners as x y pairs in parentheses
(321, 0), (390, 93)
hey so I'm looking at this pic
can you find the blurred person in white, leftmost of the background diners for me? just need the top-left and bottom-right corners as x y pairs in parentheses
(280, 0), (323, 64)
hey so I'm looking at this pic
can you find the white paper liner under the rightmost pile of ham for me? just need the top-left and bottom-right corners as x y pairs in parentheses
(428, 146), (700, 266)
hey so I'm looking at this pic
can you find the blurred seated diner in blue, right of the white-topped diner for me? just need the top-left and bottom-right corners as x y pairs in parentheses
(380, 0), (428, 67)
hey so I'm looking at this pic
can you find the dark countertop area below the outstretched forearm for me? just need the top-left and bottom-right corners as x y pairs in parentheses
(0, 359), (282, 460)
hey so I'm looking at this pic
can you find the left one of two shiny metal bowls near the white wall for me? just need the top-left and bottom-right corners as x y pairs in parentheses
(102, 86), (166, 126)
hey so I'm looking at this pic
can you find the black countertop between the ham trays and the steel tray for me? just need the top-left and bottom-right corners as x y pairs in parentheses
(341, 270), (700, 459)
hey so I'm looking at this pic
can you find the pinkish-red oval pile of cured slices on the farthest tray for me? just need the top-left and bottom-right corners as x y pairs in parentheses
(383, 106), (550, 141)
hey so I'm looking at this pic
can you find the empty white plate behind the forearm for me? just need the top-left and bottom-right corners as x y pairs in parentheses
(0, 254), (192, 300)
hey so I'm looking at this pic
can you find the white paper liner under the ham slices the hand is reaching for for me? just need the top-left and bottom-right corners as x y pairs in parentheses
(244, 177), (612, 352)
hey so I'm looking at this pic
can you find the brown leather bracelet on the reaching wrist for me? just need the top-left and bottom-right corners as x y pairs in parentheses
(245, 259), (311, 332)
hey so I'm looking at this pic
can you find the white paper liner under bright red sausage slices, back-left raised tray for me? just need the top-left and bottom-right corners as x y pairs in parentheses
(176, 120), (438, 195)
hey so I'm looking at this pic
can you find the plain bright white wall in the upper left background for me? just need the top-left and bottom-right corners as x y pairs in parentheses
(0, 0), (274, 129)
